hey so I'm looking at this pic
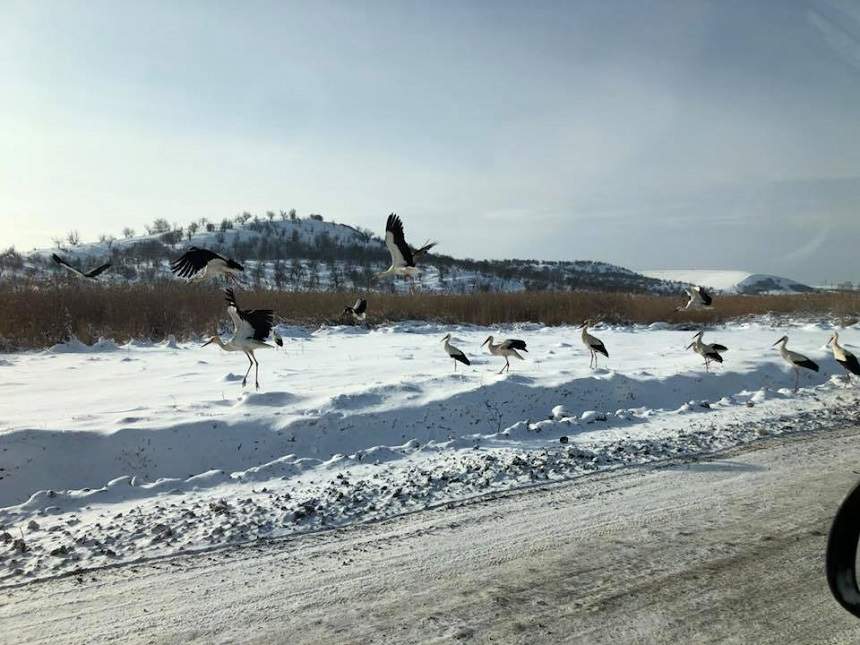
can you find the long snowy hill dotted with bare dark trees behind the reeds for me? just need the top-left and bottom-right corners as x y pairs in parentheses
(0, 213), (680, 293)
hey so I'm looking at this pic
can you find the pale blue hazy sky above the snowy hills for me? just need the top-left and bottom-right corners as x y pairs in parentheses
(0, 0), (860, 284)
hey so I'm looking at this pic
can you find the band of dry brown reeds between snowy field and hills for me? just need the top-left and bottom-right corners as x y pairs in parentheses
(0, 282), (860, 350)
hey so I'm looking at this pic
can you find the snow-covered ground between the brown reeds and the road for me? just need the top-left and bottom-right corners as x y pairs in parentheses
(0, 321), (860, 584)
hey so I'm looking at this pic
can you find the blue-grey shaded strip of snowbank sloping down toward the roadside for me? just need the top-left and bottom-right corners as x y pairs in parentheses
(0, 364), (829, 508)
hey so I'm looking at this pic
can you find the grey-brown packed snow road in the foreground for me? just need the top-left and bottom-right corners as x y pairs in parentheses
(0, 427), (860, 643)
